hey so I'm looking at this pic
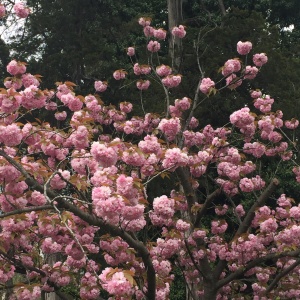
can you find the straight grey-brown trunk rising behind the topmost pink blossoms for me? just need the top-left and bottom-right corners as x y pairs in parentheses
(168, 0), (183, 72)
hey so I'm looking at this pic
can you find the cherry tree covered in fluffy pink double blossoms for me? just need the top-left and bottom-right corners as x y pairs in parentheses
(0, 5), (300, 300)
